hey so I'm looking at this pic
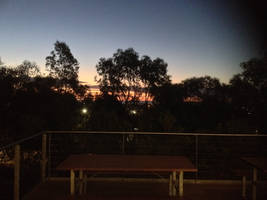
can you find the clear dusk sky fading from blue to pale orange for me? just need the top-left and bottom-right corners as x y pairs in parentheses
(0, 0), (262, 85)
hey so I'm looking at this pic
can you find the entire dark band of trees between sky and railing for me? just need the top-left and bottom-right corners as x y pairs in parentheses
(0, 41), (267, 142)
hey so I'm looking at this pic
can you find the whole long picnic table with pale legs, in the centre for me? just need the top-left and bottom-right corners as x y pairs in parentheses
(57, 154), (197, 197)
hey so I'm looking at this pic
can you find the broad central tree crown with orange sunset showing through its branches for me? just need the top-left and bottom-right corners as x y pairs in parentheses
(96, 48), (170, 103)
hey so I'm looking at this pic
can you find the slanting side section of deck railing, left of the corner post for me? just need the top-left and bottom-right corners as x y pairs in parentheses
(0, 132), (46, 200)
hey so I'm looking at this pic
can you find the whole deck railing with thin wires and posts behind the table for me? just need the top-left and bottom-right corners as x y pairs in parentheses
(0, 131), (267, 200)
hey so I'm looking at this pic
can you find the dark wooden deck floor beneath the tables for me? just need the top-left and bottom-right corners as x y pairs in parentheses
(23, 180), (267, 200)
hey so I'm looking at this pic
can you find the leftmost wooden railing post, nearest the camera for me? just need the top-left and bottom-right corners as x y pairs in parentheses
(14, 144), (20, 200)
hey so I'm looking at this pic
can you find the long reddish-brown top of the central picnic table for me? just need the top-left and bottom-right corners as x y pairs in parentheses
(57, 154), (197, 172)
